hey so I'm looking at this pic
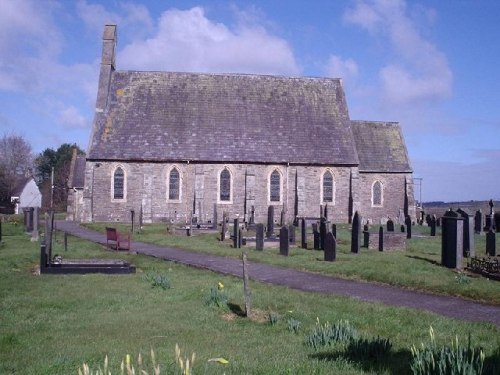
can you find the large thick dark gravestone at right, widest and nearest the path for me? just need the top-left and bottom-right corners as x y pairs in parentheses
(441, 210), (464, 269)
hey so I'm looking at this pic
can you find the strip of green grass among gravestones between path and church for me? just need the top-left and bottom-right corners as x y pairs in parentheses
(88, 224), (500, 304)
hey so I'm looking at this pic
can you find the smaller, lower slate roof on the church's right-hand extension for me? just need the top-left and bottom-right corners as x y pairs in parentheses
(351, 121), (412, 173)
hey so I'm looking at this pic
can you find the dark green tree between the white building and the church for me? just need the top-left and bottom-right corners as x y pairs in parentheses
(35, 143), (85, 211)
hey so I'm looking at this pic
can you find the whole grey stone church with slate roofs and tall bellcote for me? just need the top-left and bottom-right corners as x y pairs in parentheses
(73, 25), (415, 223)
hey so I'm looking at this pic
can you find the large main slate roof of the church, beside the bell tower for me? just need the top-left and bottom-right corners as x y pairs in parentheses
(88, 71), (358, 165)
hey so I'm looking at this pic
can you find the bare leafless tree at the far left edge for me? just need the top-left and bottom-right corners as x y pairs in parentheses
(0, 134), (33, 212)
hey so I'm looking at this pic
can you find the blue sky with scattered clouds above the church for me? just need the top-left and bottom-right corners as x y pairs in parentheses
(0, 0), (500, 202)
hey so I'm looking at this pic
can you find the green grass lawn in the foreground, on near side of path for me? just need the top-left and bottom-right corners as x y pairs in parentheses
(0, 228), (500, 375)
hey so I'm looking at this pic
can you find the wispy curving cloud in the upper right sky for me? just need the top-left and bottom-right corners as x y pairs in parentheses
(344, 0), (453, 105)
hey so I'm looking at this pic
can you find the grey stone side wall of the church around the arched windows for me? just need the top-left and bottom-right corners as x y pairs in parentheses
(82, 162), (416, 223)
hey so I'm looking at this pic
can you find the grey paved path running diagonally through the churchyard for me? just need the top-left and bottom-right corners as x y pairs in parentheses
(57, 221), (500, 327)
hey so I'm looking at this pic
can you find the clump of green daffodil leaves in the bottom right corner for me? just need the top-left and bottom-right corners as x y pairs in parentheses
(410, 327), (485, 375)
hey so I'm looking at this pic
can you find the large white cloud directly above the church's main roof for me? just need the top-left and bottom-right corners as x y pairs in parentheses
(118, 7), (300, 75)
